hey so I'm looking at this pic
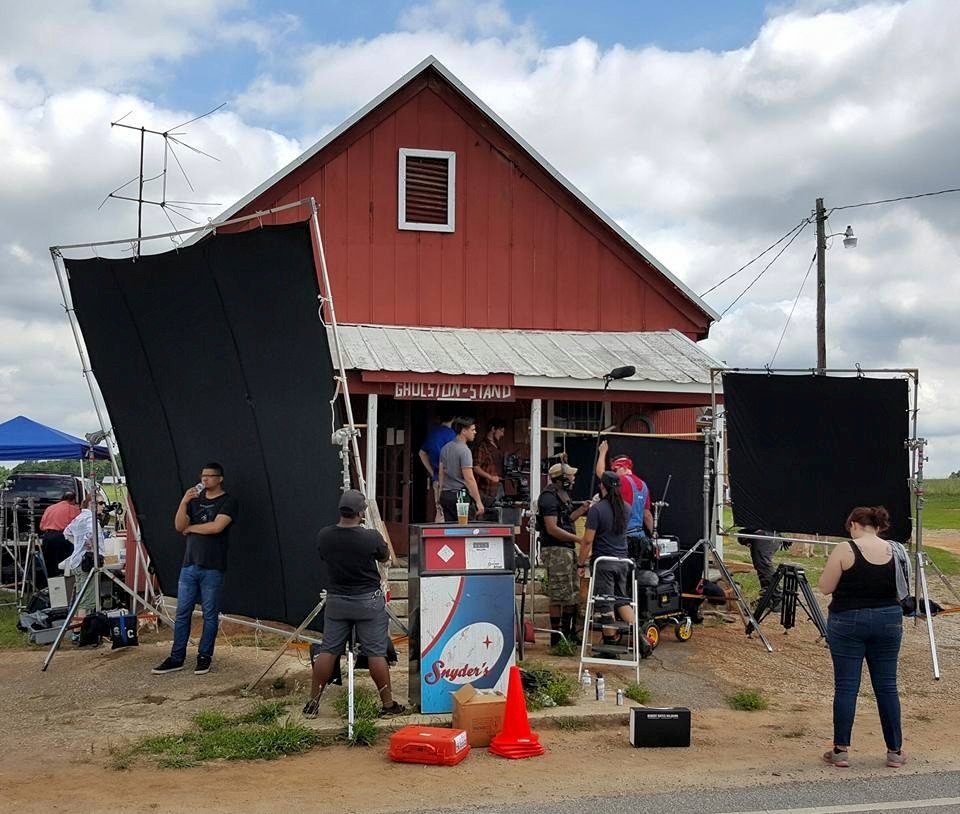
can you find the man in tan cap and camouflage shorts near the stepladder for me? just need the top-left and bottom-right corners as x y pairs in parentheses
(537, 463), (590, 646)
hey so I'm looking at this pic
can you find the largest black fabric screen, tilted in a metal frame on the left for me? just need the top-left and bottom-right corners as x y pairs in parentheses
(66, 224), (340, 624)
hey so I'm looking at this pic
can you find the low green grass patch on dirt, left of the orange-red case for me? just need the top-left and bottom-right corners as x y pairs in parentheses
(110, 702), (323, 770)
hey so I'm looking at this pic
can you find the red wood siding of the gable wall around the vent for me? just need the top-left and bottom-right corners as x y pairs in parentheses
(221, 69), (709, 338)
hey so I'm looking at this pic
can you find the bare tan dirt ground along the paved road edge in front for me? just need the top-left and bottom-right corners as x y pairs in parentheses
(0, 584), (960, 814)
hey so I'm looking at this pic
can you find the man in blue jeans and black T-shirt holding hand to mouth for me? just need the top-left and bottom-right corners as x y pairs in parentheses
(153, 463), (238, 675)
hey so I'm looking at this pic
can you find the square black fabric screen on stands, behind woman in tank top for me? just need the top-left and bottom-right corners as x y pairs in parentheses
(723, 373), (912, 541)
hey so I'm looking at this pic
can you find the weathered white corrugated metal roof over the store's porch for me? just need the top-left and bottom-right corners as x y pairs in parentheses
(327, 325), (721, 384)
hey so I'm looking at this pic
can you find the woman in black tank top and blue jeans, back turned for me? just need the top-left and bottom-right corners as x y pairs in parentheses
(820, 506), (906, 768)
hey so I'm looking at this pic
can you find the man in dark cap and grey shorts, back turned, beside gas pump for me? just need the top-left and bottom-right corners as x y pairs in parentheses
(303, 489), (406, 718)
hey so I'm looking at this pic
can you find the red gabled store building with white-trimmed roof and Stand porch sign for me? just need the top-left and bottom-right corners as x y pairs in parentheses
(212, 57), (718, 553)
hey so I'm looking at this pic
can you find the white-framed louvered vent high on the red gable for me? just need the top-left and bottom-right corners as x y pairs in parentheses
(397, 147), (457, 232)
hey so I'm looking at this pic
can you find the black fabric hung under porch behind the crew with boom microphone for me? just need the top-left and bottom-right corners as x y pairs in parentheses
(566, 435), (713, 591)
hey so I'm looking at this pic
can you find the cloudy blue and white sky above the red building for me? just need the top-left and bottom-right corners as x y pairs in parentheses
(0, 0), (960, 476)
